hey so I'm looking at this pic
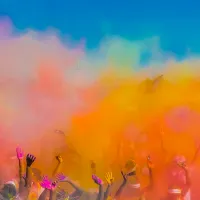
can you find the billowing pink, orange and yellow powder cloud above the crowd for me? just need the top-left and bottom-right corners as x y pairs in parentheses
(0, 17), (200, 197)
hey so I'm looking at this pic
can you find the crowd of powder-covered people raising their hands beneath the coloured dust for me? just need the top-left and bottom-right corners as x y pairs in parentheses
(0, 141), (198, 200)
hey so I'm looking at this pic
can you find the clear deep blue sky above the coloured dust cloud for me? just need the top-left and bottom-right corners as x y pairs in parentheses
(0, 0), (200, 55)
